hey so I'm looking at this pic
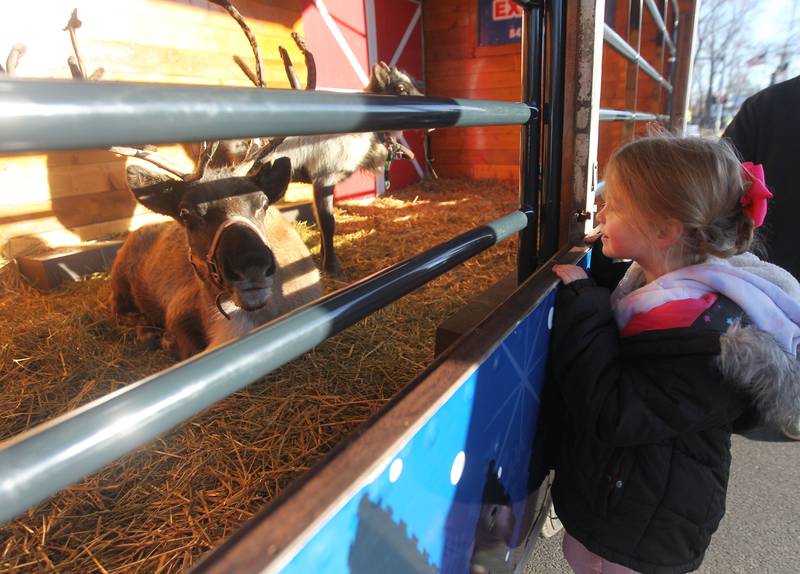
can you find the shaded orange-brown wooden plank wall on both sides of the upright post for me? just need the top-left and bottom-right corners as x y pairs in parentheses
(423, 0), (695, 181)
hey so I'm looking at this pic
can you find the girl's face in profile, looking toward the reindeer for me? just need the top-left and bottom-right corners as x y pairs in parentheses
(597, 184), (652, 263)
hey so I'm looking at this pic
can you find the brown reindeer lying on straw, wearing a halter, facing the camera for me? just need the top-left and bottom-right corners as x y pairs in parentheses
(111, 158), (323, 359)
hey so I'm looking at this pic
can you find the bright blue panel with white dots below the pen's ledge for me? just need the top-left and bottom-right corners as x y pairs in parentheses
(284, 289), (555, 574)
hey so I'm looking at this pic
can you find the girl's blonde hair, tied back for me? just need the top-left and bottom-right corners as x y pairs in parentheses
(606, 134), (753, 265)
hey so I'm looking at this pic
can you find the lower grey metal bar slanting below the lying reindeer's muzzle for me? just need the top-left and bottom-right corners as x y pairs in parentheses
(0, 211), (528, 523)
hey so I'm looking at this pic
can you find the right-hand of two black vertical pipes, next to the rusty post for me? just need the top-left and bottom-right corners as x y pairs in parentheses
(538, 0), (567, 260)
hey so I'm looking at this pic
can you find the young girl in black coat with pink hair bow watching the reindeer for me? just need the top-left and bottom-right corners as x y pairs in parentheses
(551, 136), (800, 574)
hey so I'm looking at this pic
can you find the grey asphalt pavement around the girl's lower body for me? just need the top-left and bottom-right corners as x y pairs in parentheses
(525, 431), (800, 574)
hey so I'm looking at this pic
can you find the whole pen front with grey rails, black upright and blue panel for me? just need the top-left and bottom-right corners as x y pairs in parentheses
(0, 0), (692, 572)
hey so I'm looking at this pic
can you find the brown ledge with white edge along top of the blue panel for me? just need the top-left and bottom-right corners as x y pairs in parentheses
(192, 247), (587, 574)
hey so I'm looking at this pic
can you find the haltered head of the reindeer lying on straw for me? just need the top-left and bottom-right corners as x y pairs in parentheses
(128, 157), (291, 311)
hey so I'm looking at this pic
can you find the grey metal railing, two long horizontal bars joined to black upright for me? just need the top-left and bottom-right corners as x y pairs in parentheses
(0, 1), (563, 522)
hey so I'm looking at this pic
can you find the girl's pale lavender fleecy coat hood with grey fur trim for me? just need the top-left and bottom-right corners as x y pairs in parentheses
(612, 253), (800, 428)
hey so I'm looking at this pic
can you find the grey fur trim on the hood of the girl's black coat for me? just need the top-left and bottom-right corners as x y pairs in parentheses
(717, 323), (800, 429)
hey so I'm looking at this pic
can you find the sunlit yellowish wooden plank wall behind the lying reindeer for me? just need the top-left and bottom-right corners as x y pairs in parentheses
(0, 0), (305, 264)
